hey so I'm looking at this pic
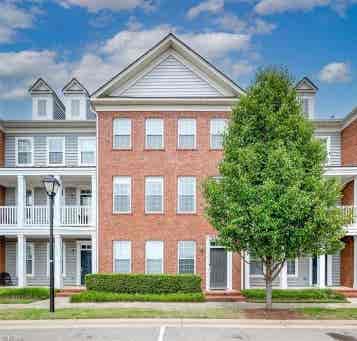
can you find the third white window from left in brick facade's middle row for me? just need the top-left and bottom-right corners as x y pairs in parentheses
(177, 176), (196, 213)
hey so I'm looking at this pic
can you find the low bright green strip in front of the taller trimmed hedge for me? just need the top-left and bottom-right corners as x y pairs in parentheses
(71, 291), (205, 303)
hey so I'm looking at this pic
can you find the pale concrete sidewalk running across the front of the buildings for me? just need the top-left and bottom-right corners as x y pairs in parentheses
(0, 297), (357, 311)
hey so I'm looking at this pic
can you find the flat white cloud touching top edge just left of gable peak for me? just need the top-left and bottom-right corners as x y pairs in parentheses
(57, 0), (155, 12)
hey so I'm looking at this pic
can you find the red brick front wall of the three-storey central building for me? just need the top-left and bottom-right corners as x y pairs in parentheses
(98, 112), (240, 289)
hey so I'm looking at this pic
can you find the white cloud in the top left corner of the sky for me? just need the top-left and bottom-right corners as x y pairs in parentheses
(0, 2), (35, 43)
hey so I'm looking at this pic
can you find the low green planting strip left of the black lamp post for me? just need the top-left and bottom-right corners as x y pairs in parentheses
(0, 288), (49, 304)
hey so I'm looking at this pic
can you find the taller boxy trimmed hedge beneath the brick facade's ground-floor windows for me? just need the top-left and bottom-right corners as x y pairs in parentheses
(86, 273), (201, 294)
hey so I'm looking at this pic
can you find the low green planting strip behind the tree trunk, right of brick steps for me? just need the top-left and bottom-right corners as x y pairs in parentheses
(242, 289), (348, 303)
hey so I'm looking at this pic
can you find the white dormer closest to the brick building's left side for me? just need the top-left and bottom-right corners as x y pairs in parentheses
(62, 78), (90, 120)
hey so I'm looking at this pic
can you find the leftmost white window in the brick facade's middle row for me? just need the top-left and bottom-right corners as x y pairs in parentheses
(113, 176), (131, 213)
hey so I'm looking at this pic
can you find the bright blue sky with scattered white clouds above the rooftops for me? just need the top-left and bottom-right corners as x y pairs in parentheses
(0, 0), (357, 119)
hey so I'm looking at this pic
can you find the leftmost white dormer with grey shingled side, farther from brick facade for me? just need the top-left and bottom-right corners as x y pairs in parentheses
(29, 78), (65, 120)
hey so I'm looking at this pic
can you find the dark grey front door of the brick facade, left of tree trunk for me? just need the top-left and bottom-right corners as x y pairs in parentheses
(210, 247), (227, 290)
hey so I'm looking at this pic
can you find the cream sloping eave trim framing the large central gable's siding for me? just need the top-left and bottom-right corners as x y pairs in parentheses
(91, 33), (245, 99)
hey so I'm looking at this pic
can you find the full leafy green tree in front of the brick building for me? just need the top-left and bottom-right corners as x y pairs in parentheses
(203, 68), (344, 309)
